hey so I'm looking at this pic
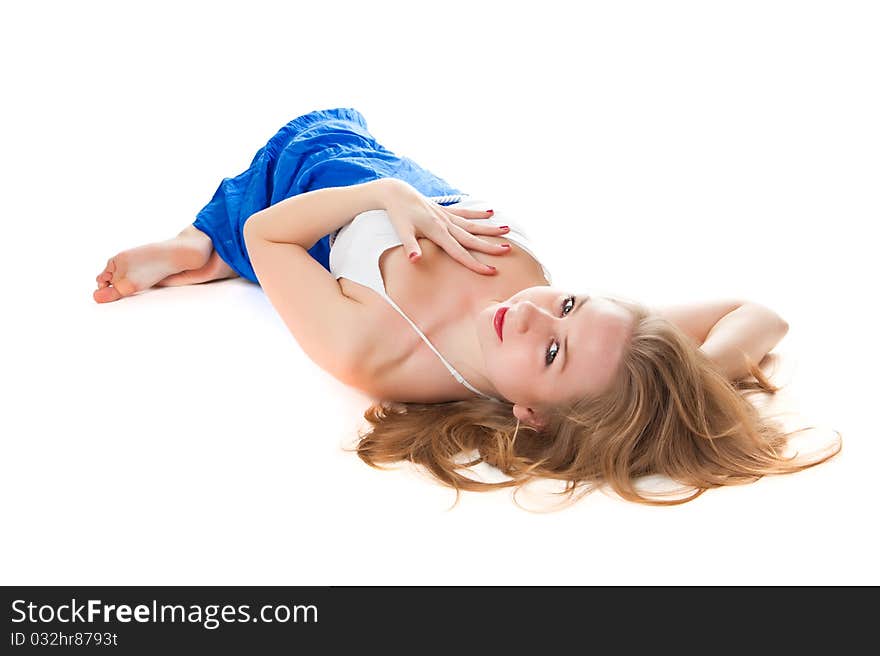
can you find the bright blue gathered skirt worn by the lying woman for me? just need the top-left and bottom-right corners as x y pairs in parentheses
(193, 108), (462, 284)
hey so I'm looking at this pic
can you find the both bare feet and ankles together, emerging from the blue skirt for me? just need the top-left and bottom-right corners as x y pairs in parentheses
(92, 225), (235, 303)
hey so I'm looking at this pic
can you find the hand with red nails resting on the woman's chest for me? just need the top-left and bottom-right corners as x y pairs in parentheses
(382, 178), (510, 275)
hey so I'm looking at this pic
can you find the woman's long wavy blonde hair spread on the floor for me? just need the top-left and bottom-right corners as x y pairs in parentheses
(354, 299), (842, 507)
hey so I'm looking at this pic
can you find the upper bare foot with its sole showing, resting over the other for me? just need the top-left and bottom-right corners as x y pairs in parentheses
(92, 236), (212, 303)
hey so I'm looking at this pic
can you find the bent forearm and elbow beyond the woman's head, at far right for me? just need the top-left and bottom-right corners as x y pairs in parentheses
(700, 303), (788, 381)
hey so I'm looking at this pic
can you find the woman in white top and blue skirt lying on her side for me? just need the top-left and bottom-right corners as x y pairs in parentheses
(94, 108), (841, 505)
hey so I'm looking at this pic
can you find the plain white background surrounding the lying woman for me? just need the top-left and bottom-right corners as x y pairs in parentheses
(0, 0), (880, 585)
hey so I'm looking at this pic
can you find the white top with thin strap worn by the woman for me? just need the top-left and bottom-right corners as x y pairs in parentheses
(330, 194), (552, 401)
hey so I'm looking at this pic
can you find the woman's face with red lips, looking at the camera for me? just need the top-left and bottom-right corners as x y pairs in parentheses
(477, 286), (634, 407)
